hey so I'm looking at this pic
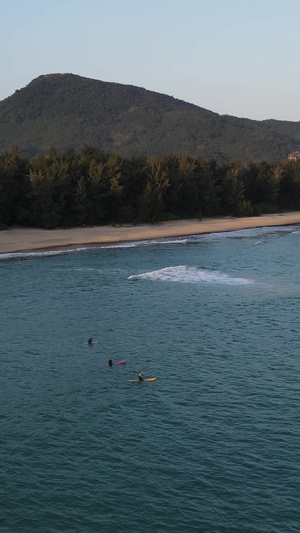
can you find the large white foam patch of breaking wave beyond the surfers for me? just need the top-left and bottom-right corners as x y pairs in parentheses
(128, 265), (254, 285)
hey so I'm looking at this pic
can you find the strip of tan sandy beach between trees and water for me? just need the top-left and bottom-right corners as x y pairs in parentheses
(0, 212), (300, 254)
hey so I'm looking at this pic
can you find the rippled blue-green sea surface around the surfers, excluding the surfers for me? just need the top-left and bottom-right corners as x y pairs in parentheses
(0, 226), (300, 533)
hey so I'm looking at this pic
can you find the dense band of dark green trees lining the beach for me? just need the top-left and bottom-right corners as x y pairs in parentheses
(0, 146), (300, 229)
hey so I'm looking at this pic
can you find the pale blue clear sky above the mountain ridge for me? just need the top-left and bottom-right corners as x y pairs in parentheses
(0, 0), (300, 121)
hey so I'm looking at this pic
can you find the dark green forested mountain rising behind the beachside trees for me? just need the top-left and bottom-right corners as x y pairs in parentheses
(0, 74), (300, 163)
